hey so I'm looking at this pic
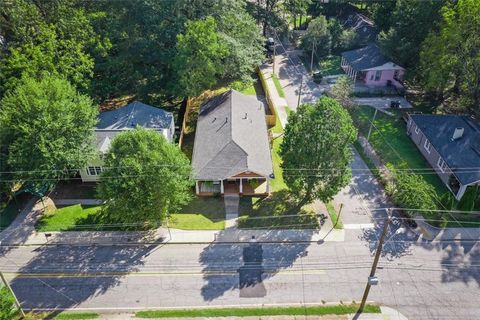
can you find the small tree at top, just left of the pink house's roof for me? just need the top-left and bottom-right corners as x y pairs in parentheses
(301, 16), (332, 56)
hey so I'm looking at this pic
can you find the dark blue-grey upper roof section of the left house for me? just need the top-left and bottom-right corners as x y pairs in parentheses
(97, 101), (173, 130)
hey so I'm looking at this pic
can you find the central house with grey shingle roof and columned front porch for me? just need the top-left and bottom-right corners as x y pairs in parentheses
(192, 90), (273, 196)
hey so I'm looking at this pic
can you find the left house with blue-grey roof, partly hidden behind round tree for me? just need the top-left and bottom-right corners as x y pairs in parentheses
(80, 101), (175, 182)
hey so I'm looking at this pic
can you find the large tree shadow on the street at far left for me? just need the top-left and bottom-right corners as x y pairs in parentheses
(11, 243), (158, 316)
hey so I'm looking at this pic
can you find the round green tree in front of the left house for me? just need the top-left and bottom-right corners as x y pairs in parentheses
(98, 128), (193, 225)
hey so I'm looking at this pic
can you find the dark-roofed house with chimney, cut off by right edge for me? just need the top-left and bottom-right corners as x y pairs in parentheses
(407, 114), (480, 200)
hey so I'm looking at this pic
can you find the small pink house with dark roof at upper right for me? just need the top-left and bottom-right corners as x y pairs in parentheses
(341, 43), (405, 89)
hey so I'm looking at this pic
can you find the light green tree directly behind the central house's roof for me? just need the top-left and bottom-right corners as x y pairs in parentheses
(175, 17), (228, 96)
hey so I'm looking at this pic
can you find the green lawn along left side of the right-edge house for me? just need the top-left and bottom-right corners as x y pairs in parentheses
(351, 106), (448, 195)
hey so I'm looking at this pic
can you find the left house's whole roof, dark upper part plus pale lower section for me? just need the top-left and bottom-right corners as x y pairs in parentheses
(95, 101), (173, 153)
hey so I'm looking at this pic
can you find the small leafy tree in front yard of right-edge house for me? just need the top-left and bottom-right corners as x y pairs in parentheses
(389, 168), (438, 216)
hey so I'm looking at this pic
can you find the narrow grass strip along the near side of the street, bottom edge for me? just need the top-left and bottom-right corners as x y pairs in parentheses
(135, 304), (380, 318)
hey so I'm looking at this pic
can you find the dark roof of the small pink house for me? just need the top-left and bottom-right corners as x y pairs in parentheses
(342, 43), (402, 71)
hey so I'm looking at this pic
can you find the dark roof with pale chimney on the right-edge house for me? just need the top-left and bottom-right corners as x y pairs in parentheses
(410, 114), (480, 185)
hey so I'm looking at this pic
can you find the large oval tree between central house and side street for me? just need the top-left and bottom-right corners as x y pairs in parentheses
(280, 97), (357, 204)
